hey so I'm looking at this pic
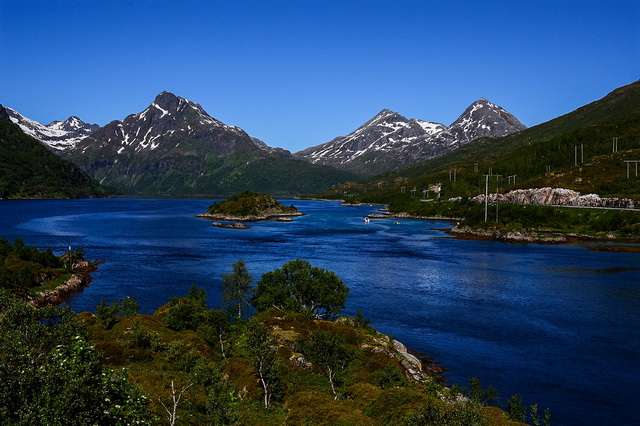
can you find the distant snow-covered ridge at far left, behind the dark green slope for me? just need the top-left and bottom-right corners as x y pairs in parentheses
(5, 108), (100, 153)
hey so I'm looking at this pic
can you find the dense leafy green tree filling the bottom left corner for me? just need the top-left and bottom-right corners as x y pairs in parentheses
(0, 292), (151, 425)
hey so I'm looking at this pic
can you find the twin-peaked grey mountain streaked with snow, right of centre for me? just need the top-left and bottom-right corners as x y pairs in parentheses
(294, 98), (526, 176)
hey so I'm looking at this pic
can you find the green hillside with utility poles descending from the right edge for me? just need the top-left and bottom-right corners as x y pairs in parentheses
(322, 81), (640, 204)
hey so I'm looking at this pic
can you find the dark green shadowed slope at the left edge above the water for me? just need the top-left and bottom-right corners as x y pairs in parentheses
(0, 105), (107, 198)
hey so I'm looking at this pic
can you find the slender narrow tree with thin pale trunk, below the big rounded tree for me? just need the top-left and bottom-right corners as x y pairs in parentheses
(246, 318), (280, 408)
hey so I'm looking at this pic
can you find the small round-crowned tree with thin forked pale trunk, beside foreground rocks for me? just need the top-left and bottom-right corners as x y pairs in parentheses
(301, 330), (355, 399)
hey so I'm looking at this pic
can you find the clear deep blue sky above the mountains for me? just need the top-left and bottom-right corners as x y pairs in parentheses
(0, 0), (640, 151)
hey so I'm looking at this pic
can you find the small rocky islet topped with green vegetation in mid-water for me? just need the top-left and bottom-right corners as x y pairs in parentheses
(197, 191), (302, 223)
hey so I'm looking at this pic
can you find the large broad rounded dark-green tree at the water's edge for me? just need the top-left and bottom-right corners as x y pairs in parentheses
(253, 259), (349, 318)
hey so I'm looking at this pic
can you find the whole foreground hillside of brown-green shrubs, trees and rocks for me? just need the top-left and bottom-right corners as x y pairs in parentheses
(0, 255), (549, 425)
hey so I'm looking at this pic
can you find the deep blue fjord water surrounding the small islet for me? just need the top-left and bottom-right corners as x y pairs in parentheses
(0, 199), (640, 425)
